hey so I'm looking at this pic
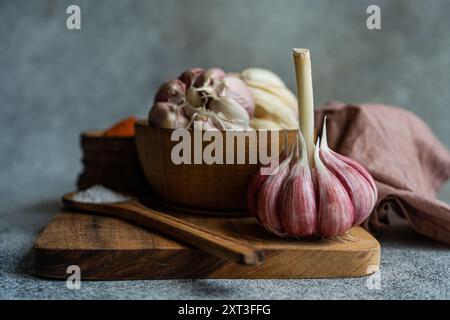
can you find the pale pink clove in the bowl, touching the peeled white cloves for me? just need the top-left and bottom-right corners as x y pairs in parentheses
(219, 75), (255, 117)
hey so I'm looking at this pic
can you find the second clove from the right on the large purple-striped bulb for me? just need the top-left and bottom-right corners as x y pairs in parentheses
(314, 139), (355, 237)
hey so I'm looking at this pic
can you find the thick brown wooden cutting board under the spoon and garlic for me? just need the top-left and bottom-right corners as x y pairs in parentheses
(34, 211), (380, 279)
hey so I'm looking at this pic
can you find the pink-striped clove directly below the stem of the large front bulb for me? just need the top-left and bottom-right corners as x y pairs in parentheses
(280, 132), (317, 237)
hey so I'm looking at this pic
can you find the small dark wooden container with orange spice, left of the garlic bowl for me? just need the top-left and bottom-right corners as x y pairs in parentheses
(77, 131), (148, 193)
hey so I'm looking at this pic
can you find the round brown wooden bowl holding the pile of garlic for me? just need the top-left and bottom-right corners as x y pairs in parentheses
(136, 121), (297, 213)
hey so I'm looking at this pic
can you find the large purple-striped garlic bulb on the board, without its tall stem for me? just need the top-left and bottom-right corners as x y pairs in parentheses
(248, 118), (378, 238)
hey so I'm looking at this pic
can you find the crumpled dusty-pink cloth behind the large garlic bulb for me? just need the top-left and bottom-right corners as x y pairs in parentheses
(315, 102), (450, 245)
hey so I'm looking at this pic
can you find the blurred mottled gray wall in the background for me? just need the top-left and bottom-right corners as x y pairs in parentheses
(0, 0), (450, 203)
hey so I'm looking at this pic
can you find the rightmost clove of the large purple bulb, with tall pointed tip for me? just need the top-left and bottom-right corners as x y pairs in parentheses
(320, 117), (377, 225)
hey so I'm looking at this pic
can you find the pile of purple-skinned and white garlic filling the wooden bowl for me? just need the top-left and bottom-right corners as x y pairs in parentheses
(149, 68), (298, 130)
